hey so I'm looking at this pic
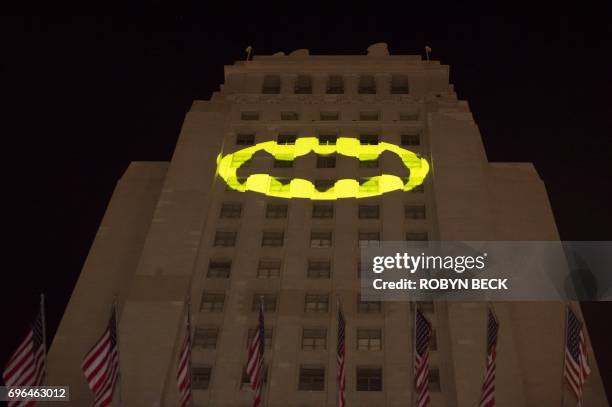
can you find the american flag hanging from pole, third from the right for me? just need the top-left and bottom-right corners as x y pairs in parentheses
(414, 307), (431, 407)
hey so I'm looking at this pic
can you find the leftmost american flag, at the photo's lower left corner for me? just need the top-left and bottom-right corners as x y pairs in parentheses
(2, 312), (47, 407)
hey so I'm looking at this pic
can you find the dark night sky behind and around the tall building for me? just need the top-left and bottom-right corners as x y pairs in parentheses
(0, 15), (612, 394)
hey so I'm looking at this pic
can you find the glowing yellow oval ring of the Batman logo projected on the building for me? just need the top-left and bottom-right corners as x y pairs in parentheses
(217, 137), (429, 200)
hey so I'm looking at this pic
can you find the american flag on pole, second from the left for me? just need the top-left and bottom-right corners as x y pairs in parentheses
(81, 306), (119, 407)
